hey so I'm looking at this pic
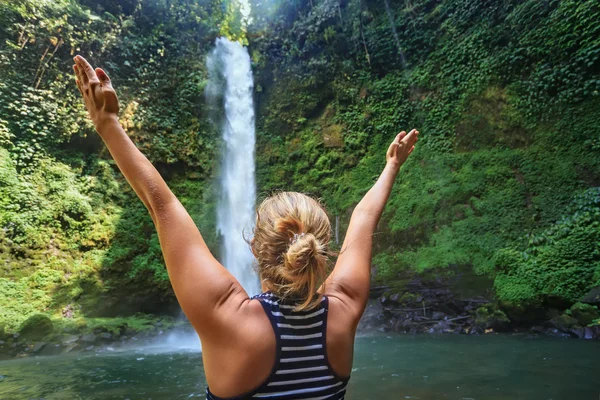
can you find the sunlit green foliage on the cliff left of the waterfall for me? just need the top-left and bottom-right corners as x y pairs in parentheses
(0, 0), (223, 324)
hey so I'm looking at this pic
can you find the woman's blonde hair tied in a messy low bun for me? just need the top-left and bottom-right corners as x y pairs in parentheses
(250, 192), (331, 311)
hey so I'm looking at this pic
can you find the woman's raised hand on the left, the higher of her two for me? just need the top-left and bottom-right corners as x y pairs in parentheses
(73, 55), (119, 132)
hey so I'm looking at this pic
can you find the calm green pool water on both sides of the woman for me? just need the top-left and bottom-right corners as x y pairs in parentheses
(0, 335), (600, 400)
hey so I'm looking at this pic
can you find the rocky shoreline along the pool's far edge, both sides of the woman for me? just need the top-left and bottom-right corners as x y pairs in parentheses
(0, 271), (600, 360)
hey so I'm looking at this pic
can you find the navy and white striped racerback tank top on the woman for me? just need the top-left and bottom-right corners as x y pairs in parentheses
(206, 292), (349, 400)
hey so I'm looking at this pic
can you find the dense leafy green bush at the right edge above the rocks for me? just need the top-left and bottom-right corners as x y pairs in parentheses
(494, 188), (600, 304)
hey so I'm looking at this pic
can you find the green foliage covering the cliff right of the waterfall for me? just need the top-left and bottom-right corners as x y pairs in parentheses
(249, 0), (600, 312)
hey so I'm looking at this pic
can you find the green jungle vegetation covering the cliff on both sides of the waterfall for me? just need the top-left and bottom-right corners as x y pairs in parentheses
(0, 0), (600, 330)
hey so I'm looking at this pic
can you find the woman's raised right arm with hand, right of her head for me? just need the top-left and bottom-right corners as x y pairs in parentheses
(325, 129), (419, 324)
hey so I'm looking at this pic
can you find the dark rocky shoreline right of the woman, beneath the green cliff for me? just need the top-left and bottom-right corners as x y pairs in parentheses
(359, 274), (600, 340)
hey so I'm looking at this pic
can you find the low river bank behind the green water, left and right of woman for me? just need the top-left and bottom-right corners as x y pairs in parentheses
(0, 300), (600, 360)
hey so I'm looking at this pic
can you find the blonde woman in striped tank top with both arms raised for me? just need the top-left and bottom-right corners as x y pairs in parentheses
(73, 56), (419, 399)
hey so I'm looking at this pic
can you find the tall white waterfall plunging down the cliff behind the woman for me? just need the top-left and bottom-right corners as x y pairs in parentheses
(206, 38), (260, 296)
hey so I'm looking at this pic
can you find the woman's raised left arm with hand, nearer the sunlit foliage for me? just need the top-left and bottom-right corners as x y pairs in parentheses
(73, 56), (248, 336)
